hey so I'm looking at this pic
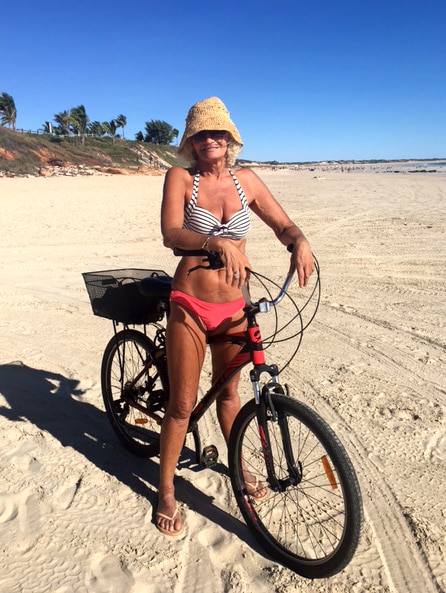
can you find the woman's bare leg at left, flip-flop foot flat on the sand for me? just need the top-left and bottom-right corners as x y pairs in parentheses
(155, 303), (206, 533)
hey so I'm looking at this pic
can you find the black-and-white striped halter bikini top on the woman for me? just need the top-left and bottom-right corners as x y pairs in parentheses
(183, 169), (251, 241)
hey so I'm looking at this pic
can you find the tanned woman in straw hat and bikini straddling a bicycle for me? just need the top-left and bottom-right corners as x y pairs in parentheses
(155, 97), (314, 536)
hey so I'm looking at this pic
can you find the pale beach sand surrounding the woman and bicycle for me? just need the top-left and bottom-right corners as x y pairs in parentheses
(0, 170), (446, 593)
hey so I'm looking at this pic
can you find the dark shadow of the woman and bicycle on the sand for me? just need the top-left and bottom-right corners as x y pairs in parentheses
(0, 362), (267, 557)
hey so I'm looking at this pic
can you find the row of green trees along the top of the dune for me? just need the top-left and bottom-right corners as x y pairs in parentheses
(0, 93), (179, 144)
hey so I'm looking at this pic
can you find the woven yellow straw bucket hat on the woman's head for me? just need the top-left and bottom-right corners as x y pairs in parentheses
(178, 97), (243, 152)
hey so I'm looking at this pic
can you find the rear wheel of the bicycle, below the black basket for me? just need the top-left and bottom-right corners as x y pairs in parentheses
(101, 329), (168, 457)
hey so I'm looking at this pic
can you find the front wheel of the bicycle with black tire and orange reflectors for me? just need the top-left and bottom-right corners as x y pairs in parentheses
(228, 388), (363, 579)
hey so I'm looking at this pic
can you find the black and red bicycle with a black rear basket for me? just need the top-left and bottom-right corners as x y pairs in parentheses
(83, 250), (363, 578)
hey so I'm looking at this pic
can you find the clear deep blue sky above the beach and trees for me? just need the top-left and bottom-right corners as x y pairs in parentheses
(0, 0), (446, 161)
